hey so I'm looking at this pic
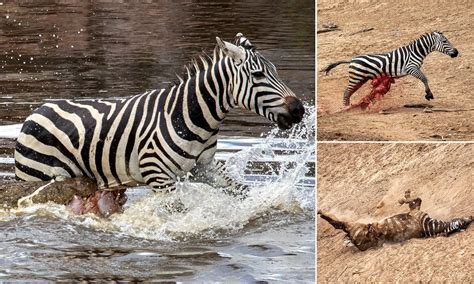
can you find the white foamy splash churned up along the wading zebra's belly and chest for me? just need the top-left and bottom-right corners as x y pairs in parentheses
(0, 106), (315, 241)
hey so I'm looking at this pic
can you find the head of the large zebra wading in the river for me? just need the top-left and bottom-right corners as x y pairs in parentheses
(216, 33), (304, 129)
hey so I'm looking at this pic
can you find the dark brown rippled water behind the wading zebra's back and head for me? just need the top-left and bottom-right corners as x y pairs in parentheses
(0, 0), (315, 136)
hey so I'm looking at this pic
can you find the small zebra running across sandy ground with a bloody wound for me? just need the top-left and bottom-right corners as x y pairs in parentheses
(321, 31), (459, 107)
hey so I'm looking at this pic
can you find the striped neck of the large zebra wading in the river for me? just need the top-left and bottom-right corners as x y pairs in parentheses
(161, 50), (236, 140)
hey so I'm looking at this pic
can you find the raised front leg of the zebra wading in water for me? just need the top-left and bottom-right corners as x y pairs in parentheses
(192, 160), (249, 199)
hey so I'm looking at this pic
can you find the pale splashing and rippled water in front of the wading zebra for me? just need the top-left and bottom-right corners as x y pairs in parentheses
(0, 107), (315, 282)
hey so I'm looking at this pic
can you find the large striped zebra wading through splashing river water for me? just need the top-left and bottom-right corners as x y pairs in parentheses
(14, 33), (304, 195)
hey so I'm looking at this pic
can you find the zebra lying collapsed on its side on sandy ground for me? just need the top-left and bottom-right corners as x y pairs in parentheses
(318, 191), (473, 251)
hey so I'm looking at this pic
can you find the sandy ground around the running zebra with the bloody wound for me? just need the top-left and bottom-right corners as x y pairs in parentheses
(317, 0), (474, 141)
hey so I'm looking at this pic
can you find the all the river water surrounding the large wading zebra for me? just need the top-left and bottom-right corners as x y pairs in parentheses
(0, 1), (315, 283)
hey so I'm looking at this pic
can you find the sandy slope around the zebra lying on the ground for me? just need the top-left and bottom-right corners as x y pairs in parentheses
(317, 144), (474, 283)
